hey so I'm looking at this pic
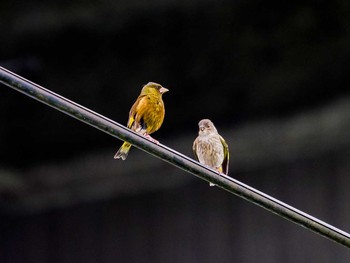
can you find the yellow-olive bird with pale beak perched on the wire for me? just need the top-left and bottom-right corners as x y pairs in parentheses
(114, 82), (169, 160)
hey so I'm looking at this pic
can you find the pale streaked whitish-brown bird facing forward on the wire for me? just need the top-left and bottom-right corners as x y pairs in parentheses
(192, 119), (229, 186)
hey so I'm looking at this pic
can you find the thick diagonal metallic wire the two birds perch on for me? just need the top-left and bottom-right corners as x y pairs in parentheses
(0, 67), (350, 248)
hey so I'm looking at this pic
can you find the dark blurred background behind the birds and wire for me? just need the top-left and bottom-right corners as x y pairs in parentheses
(0, 0), (350, 263)
